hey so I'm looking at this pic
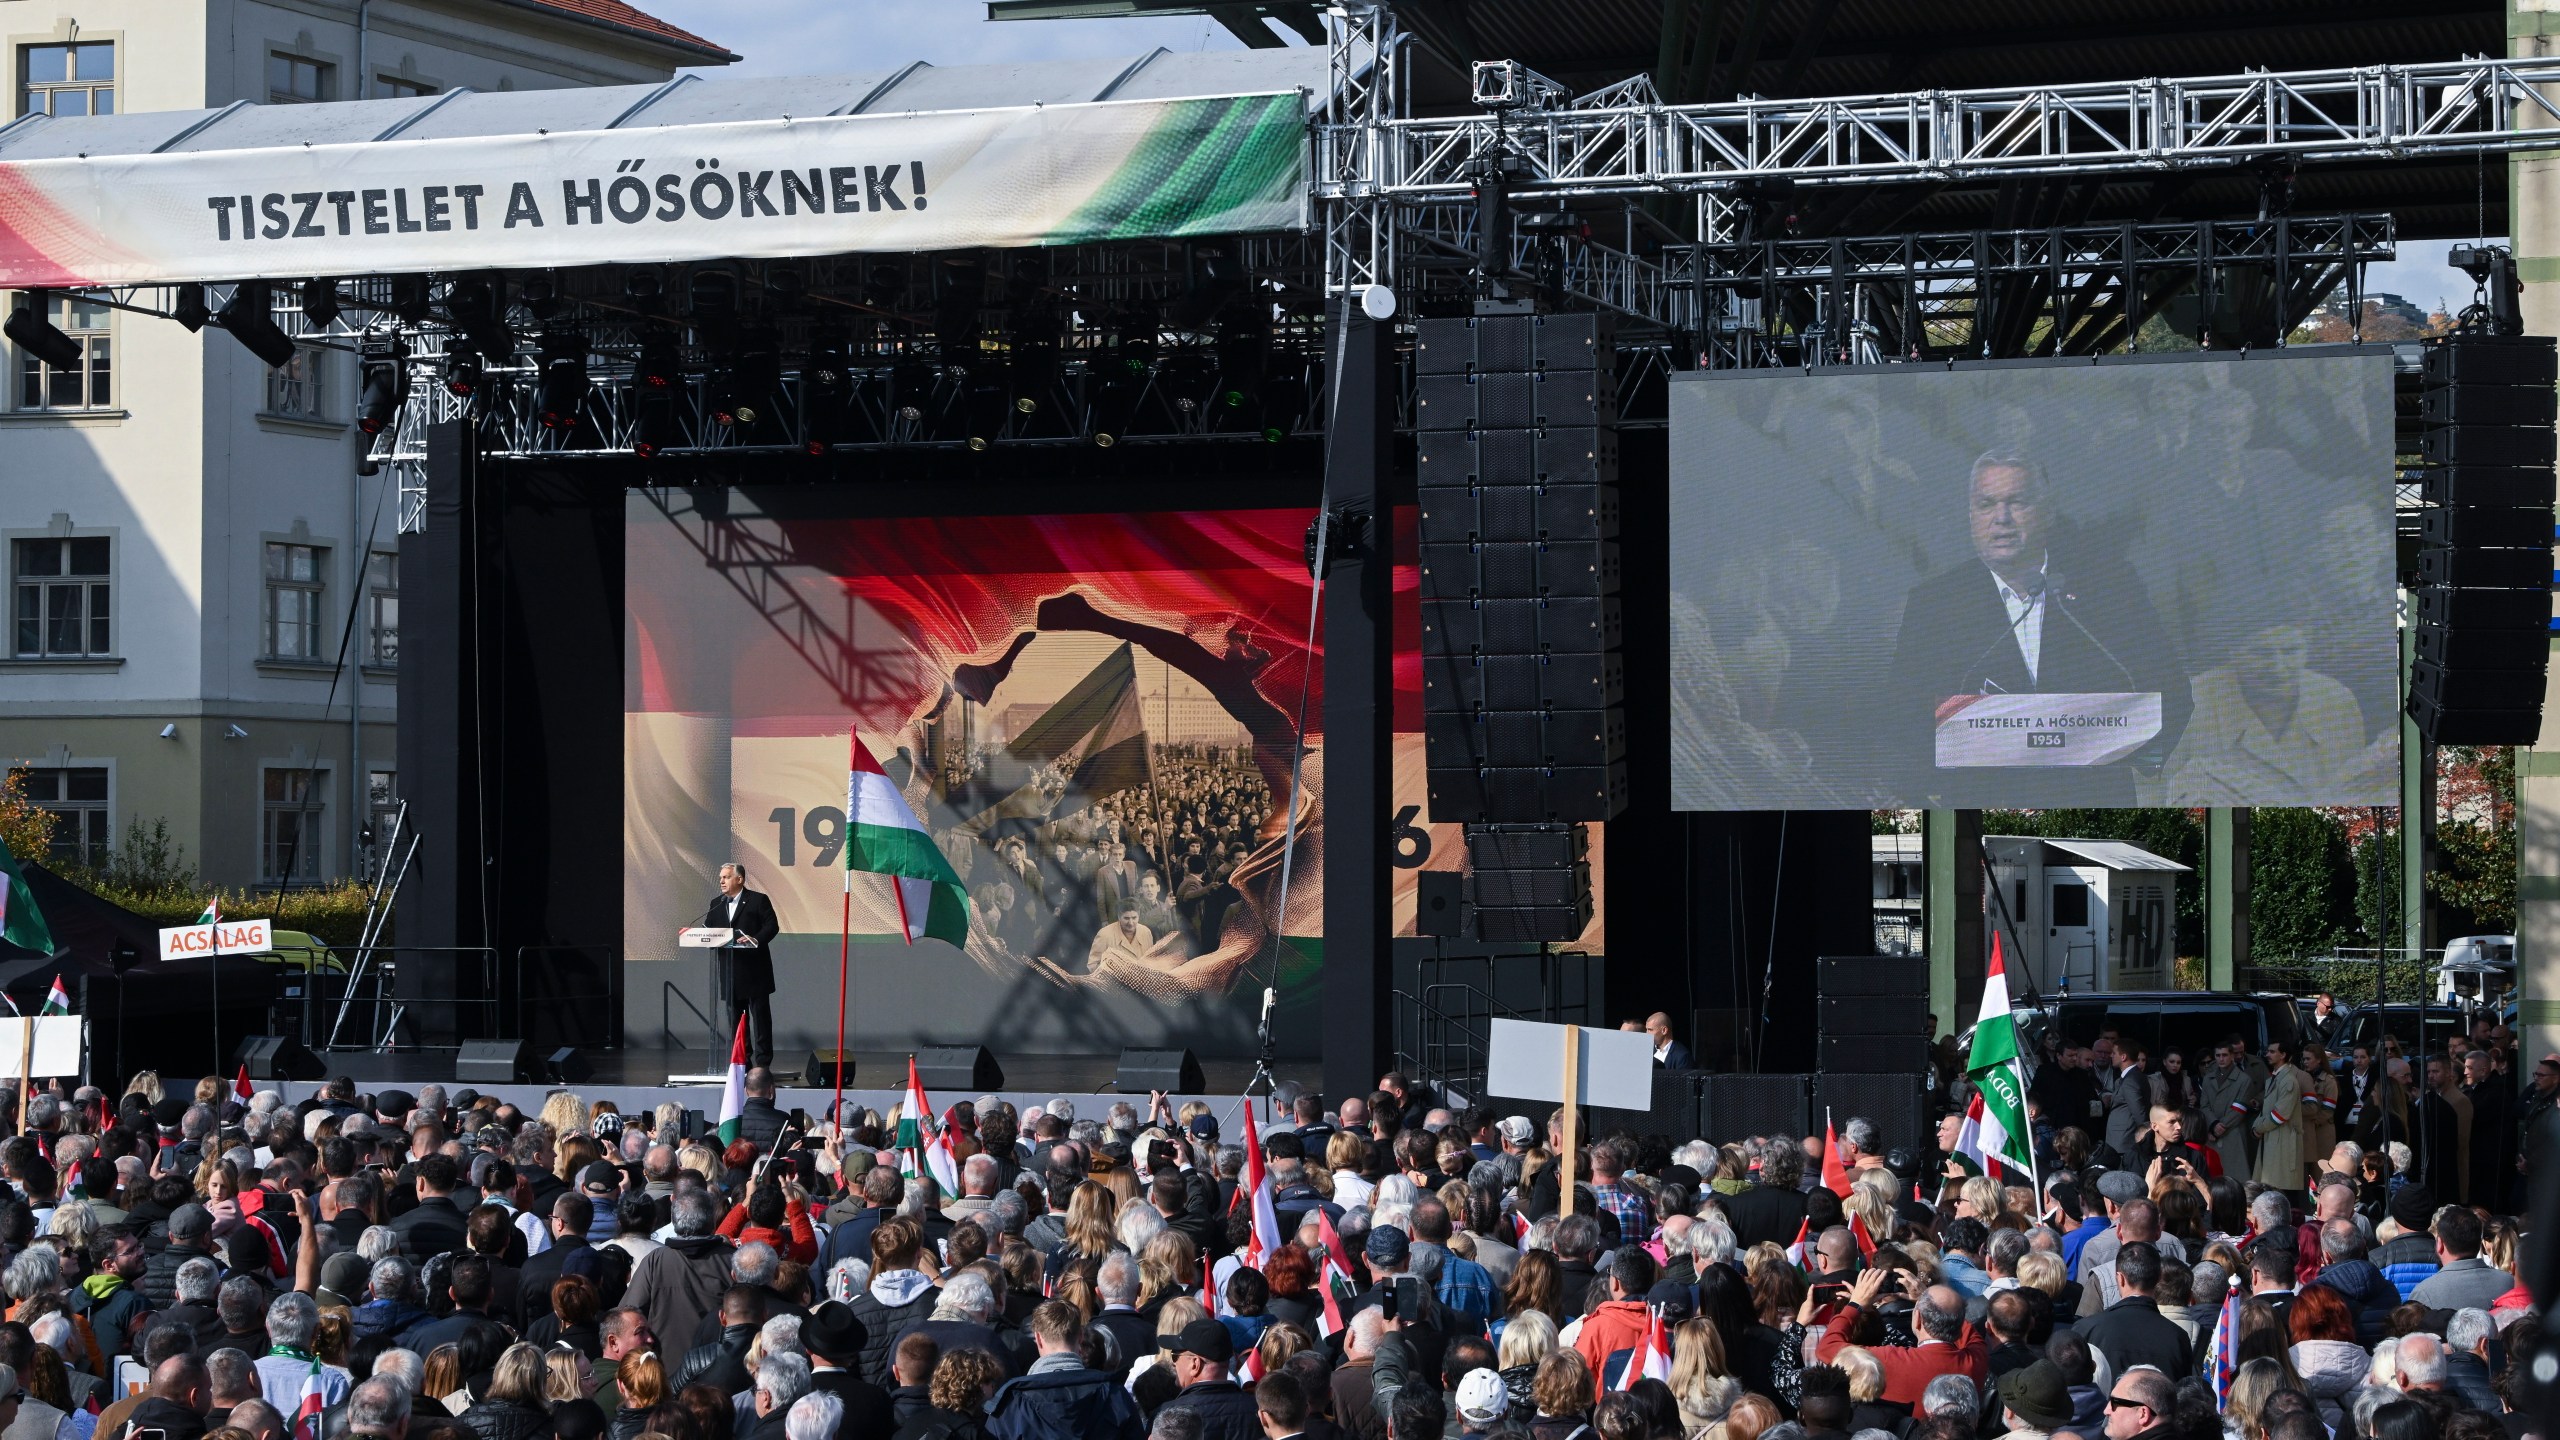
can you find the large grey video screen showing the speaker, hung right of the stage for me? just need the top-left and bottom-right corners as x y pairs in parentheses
(1669, 351), (2399, 810)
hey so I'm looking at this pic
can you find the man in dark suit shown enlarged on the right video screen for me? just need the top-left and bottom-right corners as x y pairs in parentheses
(1887, 454), (2191, 805)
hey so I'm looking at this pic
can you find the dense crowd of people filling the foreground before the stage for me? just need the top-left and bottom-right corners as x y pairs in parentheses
(0, 1051), (2542, 1440)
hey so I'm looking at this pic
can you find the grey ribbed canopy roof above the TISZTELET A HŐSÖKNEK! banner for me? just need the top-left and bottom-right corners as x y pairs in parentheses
(0, 46), (1329, 161)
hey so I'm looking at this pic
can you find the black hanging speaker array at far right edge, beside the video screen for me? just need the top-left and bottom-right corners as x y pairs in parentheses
(2409, 331), (2560, 746)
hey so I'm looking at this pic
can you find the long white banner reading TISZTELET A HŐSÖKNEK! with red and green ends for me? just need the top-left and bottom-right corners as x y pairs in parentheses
(0, 92), (1308, 290)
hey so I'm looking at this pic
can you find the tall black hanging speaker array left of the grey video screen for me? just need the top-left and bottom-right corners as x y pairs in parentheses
(1413, 315), (1626, 940)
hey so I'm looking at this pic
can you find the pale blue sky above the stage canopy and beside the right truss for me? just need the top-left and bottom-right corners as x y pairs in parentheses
(637, 0), (2470, 310)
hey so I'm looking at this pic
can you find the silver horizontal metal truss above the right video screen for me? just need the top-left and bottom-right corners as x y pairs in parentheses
(1316, 55), (2560, 221)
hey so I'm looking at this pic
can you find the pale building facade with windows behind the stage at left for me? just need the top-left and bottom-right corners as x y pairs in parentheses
(0, 0), (735, 887)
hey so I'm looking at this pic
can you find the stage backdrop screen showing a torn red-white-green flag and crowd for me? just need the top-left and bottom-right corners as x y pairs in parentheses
(622, 489), (1600, 1053)
